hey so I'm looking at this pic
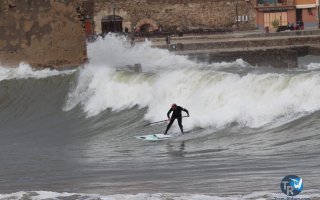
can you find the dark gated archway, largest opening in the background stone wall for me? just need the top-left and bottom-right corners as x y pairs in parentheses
(101, 15), (123, 33)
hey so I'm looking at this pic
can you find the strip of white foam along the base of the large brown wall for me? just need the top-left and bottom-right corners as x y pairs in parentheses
(0, 62), (75, 81)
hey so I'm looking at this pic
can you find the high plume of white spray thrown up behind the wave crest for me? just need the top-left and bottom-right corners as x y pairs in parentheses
(88, 34), (193, 71)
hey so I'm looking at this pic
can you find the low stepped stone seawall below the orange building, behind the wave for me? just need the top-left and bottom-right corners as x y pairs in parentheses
(153, 30), (320, 67)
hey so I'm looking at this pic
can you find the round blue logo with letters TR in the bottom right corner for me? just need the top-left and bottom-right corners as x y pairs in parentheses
(280, 175), (303, 196)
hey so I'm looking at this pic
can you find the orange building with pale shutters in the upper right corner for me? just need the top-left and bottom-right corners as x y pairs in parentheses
(255, 0), (319, 31)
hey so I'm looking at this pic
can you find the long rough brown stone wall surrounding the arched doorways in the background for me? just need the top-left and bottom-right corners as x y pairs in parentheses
(94, 0), (255, 34)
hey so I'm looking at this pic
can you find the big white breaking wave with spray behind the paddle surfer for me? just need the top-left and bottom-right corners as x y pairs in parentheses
(65, 35), (320, 129)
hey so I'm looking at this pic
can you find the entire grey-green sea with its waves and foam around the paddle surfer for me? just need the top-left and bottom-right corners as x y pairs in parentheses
(0, 36), (320, 200)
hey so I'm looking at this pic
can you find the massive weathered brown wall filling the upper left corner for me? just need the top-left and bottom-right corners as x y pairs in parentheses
(0, 0), (86, 68)
